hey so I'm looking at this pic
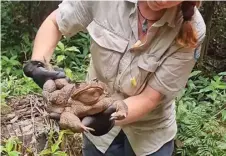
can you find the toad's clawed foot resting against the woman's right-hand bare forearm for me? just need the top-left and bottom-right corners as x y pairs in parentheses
(110, 100), (128, 120)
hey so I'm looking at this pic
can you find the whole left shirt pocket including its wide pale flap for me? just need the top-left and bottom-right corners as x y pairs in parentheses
(87, 20), (129, 81)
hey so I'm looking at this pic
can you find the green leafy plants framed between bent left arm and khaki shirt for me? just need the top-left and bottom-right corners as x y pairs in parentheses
(53, 33), (90, 80)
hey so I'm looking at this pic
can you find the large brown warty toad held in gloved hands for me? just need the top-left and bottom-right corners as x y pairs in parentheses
(43, 79), (128, 132)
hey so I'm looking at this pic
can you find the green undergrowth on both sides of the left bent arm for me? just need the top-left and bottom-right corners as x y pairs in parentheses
(1, 33), (90, 104)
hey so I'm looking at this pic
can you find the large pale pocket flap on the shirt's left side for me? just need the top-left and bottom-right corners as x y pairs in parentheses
(87, 20), (129, 53)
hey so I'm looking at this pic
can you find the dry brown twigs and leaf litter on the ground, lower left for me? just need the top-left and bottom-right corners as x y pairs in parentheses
(1, 94), (82, 156)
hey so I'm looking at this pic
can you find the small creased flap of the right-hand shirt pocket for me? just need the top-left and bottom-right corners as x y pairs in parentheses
(138, 53), (159, 72)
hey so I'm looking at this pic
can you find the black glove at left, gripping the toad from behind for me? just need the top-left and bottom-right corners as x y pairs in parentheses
(23, 61), (66, 88)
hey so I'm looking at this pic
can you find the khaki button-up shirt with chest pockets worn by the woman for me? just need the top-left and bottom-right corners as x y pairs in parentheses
(57, 0), (206, 156)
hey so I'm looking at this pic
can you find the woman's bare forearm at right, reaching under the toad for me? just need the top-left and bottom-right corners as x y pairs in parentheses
(115, 87), (162, 126)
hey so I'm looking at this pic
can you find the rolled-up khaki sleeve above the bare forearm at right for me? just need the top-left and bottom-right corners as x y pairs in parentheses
(148, 49), (195, 98)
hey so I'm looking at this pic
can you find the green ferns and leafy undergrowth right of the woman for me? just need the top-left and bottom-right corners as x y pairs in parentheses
(176, 71), (226, 156)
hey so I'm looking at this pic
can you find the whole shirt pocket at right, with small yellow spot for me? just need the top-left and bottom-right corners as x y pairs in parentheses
(118, 53), (160, 96)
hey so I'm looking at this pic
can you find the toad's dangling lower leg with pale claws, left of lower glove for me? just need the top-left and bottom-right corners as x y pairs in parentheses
(60, 112), (94, 133)
